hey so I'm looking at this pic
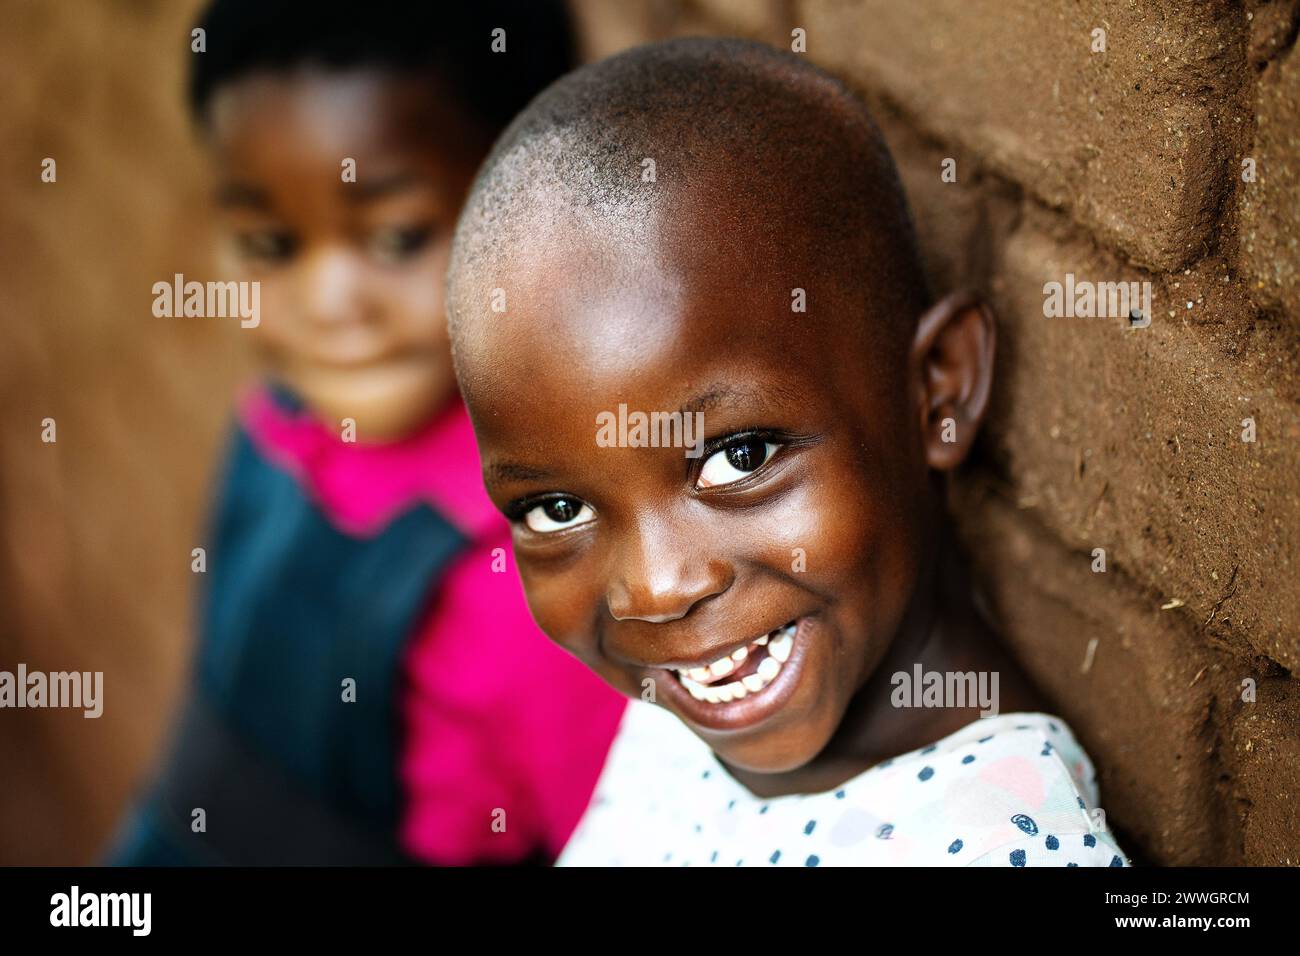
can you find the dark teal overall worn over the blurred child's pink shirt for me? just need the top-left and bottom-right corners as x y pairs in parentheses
(108, 395), (465, 866)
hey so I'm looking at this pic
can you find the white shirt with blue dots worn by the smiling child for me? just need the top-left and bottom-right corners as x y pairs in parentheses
(560, 702), (1127, 868)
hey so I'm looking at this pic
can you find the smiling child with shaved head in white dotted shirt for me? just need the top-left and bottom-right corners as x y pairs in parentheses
(449, 39), (1126, 866)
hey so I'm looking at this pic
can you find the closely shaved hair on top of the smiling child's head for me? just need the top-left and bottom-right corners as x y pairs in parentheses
(451, 38), (927, 356)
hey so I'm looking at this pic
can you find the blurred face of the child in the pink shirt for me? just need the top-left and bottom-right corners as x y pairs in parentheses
(211, 70), (486, 440)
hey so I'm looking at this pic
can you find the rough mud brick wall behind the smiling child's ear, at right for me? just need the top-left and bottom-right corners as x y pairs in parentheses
(576, 0), (1300, 865)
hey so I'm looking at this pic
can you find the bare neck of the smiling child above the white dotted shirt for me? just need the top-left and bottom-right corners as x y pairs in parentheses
(728, 528), (1047, 797)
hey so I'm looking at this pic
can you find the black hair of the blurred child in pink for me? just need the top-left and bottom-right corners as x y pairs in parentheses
(189, 0), (575, 133)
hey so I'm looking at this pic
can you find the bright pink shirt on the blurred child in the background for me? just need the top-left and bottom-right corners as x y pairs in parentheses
(241, 389), (625, 865)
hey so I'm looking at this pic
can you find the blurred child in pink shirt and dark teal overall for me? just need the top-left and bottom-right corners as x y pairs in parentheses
(112, 0), (623, 865)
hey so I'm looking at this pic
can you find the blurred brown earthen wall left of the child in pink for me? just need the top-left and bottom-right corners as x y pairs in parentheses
(0, 0), (239, 864)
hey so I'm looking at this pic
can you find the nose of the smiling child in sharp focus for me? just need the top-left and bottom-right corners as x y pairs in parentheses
(606, 519), (732, 624)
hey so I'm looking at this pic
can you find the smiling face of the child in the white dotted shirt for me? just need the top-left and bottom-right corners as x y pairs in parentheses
(458, 203), (928, 773)
